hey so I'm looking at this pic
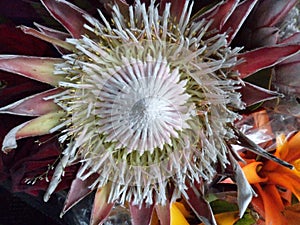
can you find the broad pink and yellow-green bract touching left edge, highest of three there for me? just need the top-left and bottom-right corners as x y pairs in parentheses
(0, 55), (64, 86)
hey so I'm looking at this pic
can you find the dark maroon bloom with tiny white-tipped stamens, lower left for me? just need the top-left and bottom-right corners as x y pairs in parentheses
(6, 136), (77, 195)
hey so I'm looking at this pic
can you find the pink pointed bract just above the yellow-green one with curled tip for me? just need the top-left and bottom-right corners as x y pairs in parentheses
(0, 88), (61, 116)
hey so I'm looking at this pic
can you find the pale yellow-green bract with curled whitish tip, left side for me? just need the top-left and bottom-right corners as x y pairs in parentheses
(2, 111), (65, 153)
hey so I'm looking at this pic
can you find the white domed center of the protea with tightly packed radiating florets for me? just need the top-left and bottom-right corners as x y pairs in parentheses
(97, 56), (189, 154)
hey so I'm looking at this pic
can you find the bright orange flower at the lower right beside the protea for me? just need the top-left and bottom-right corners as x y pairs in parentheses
(243, 132), (300, 225)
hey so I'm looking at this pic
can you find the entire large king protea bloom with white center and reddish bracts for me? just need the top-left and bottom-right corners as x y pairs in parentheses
(0, 0), (300, 224)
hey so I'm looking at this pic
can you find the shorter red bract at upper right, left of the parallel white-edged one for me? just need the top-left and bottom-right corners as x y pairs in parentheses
(196, 0), (239, 31)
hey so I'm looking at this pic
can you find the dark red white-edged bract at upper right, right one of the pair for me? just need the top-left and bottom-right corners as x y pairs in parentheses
(221, 0), (258, 43)
